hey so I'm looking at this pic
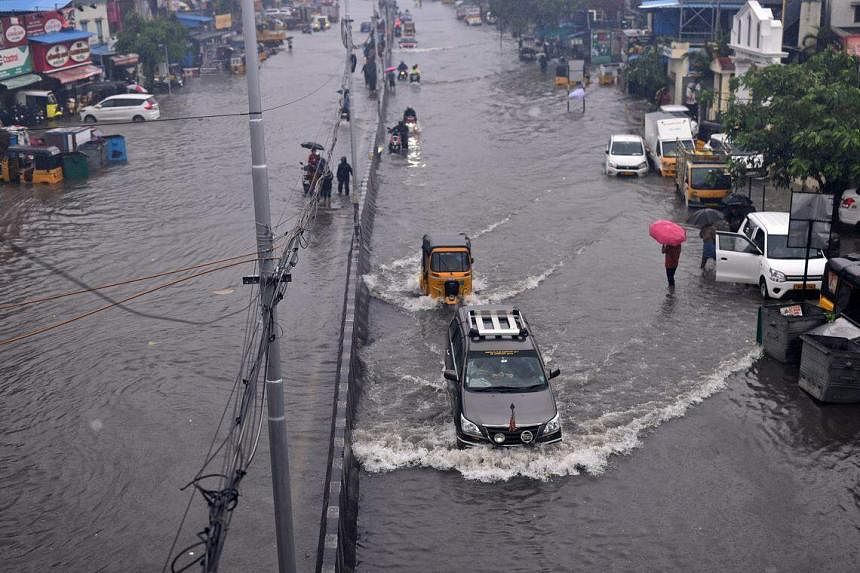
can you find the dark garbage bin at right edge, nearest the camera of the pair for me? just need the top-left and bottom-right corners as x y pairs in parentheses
(797, 334), (860, 403)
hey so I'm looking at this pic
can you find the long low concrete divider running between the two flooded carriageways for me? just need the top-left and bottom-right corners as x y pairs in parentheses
(316, 7), (391, 573)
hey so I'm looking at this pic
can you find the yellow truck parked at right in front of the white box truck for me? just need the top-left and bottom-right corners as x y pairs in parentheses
(675, 146), (732, 207)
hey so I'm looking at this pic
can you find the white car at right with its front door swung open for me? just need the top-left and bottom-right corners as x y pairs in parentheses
(716, 211), (827, 298)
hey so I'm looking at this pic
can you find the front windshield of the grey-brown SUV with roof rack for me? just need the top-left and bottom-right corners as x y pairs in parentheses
(465, 350), (547, 392)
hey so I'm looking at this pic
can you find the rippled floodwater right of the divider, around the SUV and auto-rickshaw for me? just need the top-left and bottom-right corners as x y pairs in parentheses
(354, 3), (860, 571)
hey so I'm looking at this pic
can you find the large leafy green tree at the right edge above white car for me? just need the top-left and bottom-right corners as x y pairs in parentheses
(724, 50), (860, 212)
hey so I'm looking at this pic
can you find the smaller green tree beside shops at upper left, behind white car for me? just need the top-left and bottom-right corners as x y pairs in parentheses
(117, 12), (188, 86)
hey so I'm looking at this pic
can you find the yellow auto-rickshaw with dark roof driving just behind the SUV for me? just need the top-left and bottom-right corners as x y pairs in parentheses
(418, 233), (474, 304)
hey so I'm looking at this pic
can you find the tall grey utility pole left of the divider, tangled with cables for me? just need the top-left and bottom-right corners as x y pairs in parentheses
(237, 0), (296, 573)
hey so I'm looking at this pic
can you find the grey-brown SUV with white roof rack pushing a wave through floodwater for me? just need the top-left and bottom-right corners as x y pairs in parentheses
(443, 305), (561, 448)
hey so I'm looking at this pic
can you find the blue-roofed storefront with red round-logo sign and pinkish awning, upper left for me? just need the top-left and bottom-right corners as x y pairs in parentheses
(30, 30), (102, 114)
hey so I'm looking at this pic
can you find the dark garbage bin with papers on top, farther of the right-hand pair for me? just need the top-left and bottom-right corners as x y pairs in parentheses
(762, 302), (827, 363)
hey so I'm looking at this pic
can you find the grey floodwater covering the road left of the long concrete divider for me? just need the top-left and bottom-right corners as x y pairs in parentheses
(0, 3), (375, 571)
